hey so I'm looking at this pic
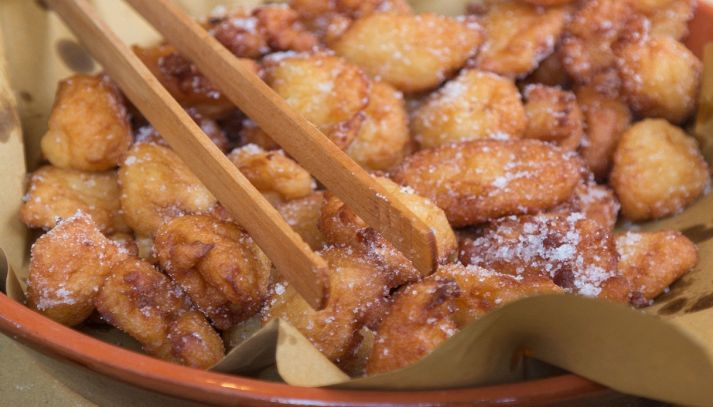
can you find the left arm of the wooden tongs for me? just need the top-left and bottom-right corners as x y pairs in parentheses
(49, 0), (328, 309)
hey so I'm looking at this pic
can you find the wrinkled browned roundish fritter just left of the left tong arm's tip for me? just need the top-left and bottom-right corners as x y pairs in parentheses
(154, 215), (272, 330)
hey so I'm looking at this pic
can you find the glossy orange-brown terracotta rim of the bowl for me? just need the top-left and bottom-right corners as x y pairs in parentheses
(0, 2), (713, 406)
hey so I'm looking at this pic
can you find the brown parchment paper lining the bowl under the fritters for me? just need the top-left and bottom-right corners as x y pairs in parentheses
(0, 0), (713, 405)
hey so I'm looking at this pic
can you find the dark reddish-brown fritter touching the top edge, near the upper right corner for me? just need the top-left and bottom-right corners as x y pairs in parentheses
(560, 0), (634, 88)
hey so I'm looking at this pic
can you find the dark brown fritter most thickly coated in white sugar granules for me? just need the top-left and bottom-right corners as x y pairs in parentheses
(460, 212), (629, 302)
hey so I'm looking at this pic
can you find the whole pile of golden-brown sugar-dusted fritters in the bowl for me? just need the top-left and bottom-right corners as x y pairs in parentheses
(21, 0), (710, 375)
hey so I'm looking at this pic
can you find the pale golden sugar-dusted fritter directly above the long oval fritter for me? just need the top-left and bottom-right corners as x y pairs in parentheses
(411, 70), (527, 148)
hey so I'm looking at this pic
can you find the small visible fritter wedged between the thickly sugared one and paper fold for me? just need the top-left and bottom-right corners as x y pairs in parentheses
(437, 264), (564, 328)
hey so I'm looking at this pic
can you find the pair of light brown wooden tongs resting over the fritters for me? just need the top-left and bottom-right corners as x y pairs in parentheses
(49, 0), (437, 309)
